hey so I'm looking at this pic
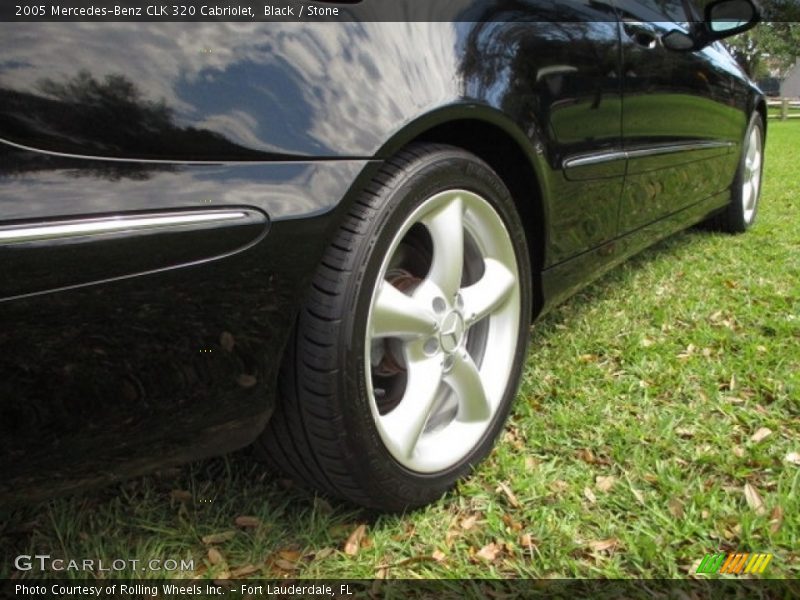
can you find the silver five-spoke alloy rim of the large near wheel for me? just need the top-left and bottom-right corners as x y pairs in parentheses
(365, 190), (521, 473)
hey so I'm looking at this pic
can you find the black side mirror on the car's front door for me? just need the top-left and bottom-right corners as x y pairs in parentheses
(661, 0), (761, 52)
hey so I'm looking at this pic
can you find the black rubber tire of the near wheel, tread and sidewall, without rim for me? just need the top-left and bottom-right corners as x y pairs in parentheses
(258, 144), (532, 511)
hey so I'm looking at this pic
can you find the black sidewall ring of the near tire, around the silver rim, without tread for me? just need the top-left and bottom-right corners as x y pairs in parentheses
(337, 149), (532, 507)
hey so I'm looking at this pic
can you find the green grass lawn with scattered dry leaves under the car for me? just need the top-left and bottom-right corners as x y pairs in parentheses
(0, 121), (800, 578)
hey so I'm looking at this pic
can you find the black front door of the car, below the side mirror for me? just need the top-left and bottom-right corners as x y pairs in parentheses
(618, 0), (742, 232)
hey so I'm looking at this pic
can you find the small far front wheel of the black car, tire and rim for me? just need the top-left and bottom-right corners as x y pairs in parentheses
(709, 113), (764, 233)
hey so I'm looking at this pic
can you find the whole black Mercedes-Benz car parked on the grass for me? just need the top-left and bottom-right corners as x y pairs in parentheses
(0, 0), (766, 510)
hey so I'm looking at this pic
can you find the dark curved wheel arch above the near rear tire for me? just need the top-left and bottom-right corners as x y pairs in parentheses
(378, 105), (549, 317)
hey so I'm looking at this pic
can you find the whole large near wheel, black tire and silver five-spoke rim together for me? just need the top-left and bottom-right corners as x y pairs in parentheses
(261, 144), (532, 510)
